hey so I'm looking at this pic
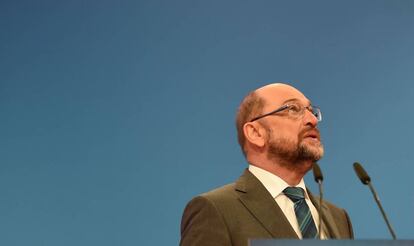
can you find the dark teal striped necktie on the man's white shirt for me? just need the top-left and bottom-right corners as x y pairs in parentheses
(283, 187), (318, 238)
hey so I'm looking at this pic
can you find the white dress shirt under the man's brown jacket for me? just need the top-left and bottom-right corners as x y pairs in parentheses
(249, 165), (326, 239)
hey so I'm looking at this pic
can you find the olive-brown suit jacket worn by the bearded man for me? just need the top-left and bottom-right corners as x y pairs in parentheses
(180, 170), (353, 246)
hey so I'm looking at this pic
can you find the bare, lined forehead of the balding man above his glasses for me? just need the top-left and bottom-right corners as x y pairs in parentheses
(256, 84), (311, 109)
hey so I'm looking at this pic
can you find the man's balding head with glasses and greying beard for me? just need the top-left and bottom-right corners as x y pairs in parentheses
(236, 83), (324, 173)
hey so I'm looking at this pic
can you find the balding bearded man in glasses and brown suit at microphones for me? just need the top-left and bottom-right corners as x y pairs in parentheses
(180, 83), (353, 246)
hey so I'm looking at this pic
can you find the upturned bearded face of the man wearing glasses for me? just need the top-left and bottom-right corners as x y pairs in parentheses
(261, 87), (324, 169)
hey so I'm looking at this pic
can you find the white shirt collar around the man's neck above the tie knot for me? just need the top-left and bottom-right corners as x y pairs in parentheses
(249, 165), (309, 199)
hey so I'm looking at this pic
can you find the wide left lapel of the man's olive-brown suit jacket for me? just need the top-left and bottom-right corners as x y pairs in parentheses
(236, 169), (298, 239)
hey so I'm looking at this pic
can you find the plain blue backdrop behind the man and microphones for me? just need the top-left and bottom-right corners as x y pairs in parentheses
(0, 0), (414, 246)
